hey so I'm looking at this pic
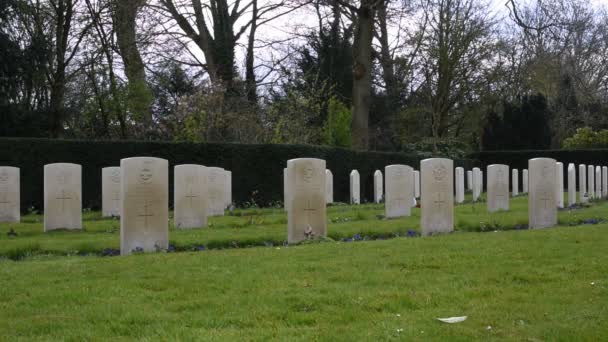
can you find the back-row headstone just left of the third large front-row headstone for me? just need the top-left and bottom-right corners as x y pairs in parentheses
(384, 165), (414, 218)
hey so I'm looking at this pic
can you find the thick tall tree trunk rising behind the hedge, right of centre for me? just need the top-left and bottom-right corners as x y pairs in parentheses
(351, 0), (374, 150)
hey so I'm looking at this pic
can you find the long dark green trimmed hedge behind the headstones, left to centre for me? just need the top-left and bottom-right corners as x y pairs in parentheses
(0, 138), (472, 211)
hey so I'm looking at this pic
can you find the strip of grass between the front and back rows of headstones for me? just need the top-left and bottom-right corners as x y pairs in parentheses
(0, 192), (608, 259)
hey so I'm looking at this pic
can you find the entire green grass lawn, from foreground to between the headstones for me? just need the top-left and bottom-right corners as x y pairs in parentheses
(0, 197), (608, 341)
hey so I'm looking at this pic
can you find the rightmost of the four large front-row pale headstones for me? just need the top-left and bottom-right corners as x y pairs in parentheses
(528, 158), (557, 228)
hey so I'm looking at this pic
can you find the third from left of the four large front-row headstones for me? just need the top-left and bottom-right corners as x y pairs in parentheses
(420, 158), (454, 235)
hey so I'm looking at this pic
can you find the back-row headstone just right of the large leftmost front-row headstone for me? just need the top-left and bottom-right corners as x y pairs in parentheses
(173, 164), (209, 229)
